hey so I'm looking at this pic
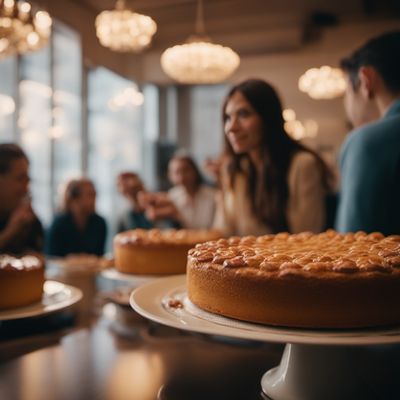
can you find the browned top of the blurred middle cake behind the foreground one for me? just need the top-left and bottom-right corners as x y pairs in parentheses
(114, 229), (221, 246)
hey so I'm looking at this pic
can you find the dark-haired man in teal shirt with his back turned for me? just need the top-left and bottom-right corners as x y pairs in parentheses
(336, 31), (400, 235)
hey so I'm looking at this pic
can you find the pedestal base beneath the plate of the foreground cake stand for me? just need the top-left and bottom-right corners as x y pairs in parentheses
(261, 344), (400, 400)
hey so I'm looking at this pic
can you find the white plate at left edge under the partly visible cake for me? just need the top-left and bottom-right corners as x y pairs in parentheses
(0, 281), (82, 321)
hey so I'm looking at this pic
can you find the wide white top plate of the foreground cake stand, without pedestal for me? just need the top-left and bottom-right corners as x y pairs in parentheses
(130, 275), (400, 345)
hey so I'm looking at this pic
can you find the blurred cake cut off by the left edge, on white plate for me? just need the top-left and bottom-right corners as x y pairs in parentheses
(0, 254), (44, 310)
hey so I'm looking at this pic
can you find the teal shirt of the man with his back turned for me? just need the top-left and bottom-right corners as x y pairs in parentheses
(335, 100), (400, 235)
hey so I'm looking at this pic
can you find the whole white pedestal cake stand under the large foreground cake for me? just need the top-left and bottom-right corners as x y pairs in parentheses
(130, 275), (400, 400)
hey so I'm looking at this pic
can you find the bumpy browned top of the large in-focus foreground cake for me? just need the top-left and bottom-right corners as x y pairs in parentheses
(189, 230), (400, 275)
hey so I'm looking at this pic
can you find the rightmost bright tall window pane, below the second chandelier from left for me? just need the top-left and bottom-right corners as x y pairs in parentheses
(88, 68), (142, 241)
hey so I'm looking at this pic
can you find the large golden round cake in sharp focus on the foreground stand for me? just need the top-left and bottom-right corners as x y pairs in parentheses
(187, 231), (400, 328)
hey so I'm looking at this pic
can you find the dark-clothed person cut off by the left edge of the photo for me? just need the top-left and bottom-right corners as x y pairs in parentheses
(0, 143), (43, 255)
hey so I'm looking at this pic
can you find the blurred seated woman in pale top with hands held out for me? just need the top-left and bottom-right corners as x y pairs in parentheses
(140, 152), (216, 229)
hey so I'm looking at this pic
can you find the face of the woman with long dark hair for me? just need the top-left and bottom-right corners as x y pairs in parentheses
(224, 92), (263, 154)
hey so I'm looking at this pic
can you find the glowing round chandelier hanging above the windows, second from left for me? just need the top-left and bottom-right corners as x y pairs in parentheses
(96, 0), (157, 53)
